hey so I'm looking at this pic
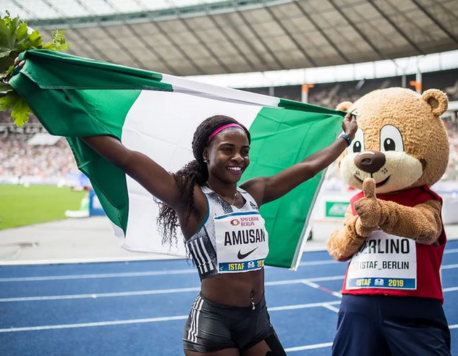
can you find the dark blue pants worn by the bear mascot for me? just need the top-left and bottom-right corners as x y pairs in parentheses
(332, 295), (451, 356)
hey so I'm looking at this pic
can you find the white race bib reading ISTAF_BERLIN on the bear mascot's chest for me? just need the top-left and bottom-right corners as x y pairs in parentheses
(346, 230), (417, 289)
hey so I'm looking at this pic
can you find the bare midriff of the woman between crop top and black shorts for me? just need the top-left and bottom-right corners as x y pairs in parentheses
(202, 268), (264, 307)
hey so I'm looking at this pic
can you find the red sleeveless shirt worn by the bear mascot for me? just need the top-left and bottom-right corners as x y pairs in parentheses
(342, 186), (447, 302)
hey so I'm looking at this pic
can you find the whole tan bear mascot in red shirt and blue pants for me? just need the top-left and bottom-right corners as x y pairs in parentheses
(327, 88), (450, 356)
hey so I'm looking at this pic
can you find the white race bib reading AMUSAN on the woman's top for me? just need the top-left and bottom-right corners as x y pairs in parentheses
(215, 211), (269, 273)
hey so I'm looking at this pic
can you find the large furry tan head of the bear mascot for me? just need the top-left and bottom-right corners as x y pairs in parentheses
(337, 88), (449, 193)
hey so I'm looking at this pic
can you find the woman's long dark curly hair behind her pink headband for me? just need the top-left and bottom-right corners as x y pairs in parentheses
(156, 115), (251, 244)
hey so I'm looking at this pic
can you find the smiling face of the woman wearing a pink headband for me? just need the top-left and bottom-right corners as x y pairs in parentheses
(204, 128), (250, 183)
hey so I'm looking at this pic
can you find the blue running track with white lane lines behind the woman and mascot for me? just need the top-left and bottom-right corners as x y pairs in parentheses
(0, 241), (458, 356)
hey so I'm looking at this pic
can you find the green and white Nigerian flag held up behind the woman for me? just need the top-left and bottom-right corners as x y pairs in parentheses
(10, 50), (343, 269)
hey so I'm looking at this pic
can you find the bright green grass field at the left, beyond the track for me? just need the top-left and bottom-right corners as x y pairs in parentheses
(0, 185), (86, 230)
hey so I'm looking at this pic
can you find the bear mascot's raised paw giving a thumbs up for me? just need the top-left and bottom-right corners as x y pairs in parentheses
(355, 178), (382, 236)
